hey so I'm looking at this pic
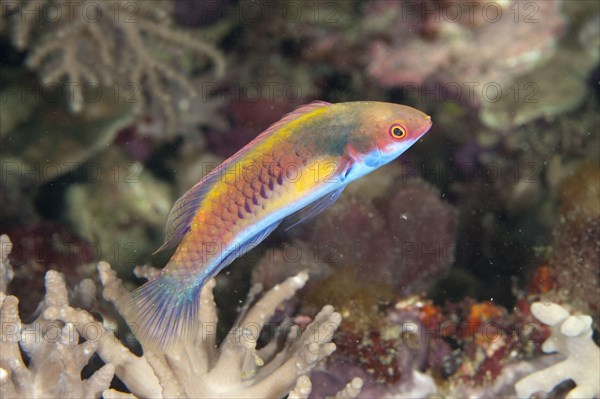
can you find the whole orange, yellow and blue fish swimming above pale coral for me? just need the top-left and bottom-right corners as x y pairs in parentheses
(124, 101), (431, 350)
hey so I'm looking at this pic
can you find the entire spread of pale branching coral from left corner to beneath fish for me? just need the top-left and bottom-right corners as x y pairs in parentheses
(0, 236), (362, 398)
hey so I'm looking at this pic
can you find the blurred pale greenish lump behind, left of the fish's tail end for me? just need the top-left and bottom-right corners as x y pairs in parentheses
(64, 147), (174, 275)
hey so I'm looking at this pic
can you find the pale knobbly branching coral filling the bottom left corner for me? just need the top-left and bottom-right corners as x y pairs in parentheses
(0, 271), (115, 399)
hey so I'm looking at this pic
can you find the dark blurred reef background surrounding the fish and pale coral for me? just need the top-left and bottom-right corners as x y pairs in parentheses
(0, 0), (600, 398)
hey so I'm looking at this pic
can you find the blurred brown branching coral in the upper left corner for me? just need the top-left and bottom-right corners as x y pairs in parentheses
(0, 0), (225, 132)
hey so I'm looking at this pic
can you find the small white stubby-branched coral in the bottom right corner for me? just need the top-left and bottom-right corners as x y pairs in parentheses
(515, 302), (600, 399)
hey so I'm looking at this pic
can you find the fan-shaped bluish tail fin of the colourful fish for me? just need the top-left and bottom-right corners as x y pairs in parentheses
(123, 274), (202, 352)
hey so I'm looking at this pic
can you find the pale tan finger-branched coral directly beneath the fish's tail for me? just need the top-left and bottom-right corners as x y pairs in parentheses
(91, 263), (350, 398)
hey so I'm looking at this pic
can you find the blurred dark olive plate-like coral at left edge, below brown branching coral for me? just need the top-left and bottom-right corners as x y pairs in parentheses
(0, 73), (134, 190)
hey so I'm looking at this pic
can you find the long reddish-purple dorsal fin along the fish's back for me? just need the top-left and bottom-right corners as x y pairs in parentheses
(154, 101), (331, 253)
